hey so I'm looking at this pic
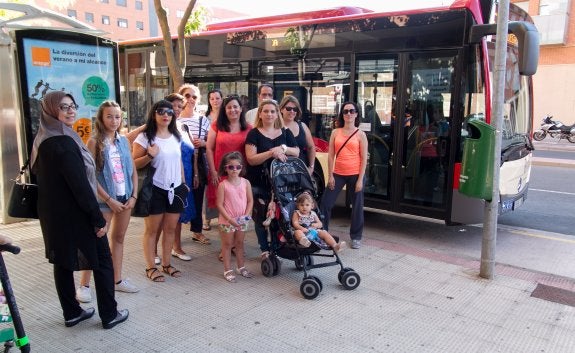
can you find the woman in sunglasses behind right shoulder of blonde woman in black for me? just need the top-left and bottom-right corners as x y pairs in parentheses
(280, 95), (315, 175)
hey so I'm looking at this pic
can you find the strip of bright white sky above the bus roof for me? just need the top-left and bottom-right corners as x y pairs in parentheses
(196, 0), (460, 17)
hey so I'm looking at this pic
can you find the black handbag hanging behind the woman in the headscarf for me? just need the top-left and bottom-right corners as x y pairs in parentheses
(8, 160), (38, 218)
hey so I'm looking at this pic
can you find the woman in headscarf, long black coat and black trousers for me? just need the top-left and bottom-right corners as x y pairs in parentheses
(30, 91), (129, 329)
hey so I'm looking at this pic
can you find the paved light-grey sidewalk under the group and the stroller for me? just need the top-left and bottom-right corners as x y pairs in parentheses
(0, 217), (575, 353)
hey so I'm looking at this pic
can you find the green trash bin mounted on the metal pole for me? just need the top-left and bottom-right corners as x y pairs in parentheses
(459, 120), (495, 201)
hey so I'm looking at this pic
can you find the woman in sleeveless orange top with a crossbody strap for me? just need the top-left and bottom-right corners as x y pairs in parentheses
(321, 102), (367, 249)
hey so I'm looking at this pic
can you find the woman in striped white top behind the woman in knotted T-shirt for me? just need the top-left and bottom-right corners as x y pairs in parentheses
(178, 83), (211, 245)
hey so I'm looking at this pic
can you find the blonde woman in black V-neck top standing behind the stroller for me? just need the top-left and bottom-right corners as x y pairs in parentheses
(245, 100), (299, 258)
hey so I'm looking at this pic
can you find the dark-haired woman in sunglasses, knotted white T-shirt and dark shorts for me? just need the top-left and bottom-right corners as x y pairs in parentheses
(132, 100), (190, 282)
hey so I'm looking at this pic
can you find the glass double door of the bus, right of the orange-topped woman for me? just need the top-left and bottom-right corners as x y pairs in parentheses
(356, 51), (457, 219)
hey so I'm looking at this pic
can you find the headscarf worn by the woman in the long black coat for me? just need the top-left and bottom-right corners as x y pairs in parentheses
(30, 91), (97, 195)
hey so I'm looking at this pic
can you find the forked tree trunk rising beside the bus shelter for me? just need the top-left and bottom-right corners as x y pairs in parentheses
(154, 0), (208, 87)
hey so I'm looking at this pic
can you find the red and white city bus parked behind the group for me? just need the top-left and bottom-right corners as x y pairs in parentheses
(119, 0), (538, 224)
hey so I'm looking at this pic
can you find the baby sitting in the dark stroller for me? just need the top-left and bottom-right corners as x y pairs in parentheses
(291, 191), (346, 252)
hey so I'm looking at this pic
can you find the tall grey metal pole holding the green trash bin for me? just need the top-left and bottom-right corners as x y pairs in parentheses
(479, 0), (509, 279)
